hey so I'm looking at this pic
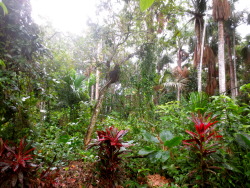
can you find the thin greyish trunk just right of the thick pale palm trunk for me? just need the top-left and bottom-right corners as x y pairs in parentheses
(227, 36), (235, 99)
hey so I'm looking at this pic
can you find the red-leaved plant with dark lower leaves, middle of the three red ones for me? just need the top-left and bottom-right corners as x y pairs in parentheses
(89, 126), (129, 188)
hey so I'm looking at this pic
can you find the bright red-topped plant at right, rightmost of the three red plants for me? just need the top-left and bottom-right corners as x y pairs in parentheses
(183, 114), (222, 187)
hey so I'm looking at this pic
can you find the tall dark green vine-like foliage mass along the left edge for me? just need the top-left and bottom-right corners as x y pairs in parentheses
(0, 0), (46, 140)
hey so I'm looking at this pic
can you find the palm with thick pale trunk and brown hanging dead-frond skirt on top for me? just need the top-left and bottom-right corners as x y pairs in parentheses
(213, 0), (230, 94)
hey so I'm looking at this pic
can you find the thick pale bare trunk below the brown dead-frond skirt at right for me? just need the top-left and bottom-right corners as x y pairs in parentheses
(218, 20), (226, 95)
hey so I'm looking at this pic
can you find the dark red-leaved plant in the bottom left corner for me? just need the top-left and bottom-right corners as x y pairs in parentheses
(0, 138), (58, 187)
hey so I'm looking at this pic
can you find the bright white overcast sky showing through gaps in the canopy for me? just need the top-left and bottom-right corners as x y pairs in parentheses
(31, 0), (250, 38)
